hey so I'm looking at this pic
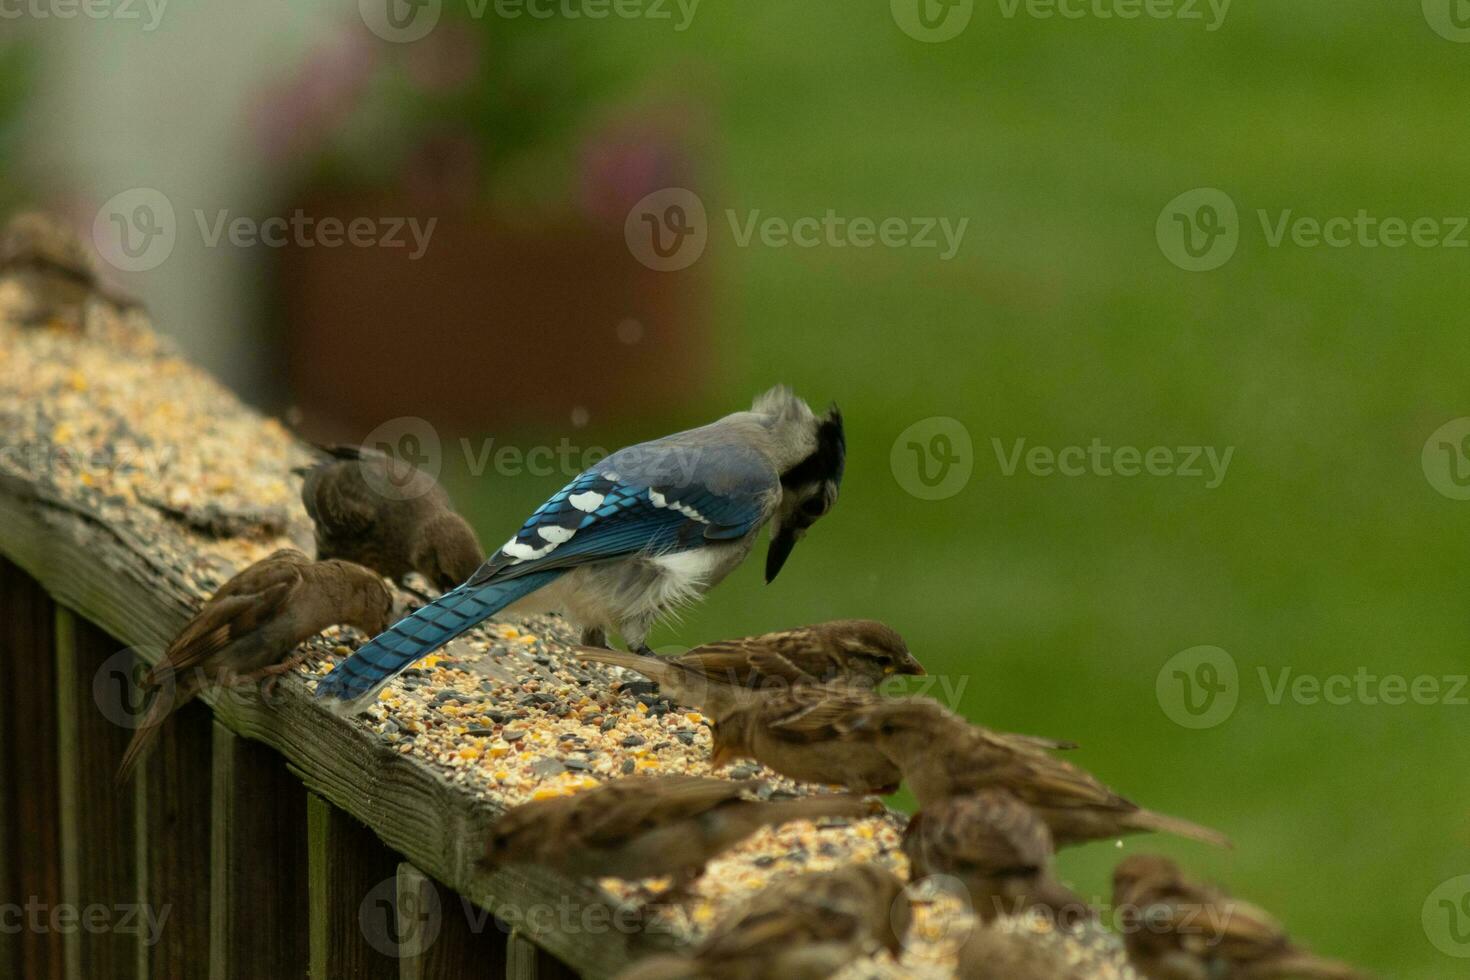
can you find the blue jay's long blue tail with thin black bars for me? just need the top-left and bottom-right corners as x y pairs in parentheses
(316, 570), (563, 701)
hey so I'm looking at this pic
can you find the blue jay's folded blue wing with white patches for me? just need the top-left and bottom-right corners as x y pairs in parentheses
(470, 444), (778, 585)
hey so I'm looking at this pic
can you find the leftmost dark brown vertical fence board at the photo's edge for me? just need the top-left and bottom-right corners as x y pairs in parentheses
(0, 558), (65, 980)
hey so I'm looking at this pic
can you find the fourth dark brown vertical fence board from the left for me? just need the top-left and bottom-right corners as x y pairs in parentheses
(209, 723), (309, 980)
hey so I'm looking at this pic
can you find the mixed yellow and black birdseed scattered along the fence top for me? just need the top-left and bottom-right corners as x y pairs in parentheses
(0, 295), (1132, 977)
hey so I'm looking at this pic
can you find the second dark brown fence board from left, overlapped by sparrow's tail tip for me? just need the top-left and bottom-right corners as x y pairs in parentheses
(56, 608), (139, 980)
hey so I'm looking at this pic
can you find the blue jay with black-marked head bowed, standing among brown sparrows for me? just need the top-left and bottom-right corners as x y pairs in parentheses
(316, 386), (847, 702)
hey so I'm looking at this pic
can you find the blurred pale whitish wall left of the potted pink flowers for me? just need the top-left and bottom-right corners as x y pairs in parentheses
(24, 0), (345, 398)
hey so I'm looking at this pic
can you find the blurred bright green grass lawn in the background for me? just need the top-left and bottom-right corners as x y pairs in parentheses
(435, 0), (1470, 979)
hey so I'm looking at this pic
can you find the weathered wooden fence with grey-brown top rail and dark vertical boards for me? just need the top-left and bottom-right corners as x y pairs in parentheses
(0, 319), (666, 980)
